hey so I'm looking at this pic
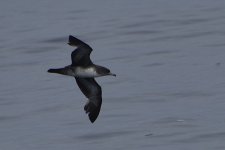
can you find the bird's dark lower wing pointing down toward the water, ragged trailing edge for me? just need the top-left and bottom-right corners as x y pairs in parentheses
(75, 77), (102, 123)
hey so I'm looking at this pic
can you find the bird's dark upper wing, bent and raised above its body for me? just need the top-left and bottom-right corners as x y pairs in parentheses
(68, 35), (93, 67)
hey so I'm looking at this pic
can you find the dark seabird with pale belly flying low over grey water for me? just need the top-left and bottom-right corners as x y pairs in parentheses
(48, 35), (116, 123)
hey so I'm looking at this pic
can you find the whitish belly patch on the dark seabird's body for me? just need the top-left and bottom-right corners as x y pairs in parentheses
(75, 67), (99, 77)
